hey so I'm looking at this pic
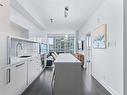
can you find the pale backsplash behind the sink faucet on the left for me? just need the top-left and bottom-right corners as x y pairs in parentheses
(10, 39), (39, 57)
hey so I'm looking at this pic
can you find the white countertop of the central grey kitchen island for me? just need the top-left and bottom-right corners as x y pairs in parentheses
(54, 53), (81, 63)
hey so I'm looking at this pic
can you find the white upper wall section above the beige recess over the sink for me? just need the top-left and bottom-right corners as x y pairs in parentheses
(10, 7), (45, 42)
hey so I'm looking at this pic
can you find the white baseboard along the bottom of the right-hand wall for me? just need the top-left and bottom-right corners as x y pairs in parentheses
(91, 74), (119, 95)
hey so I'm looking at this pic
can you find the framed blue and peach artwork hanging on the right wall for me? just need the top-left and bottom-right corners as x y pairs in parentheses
(92, 24), (107, 49)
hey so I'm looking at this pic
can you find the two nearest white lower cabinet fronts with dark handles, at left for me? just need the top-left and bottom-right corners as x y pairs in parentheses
(0, 61), (27, 95)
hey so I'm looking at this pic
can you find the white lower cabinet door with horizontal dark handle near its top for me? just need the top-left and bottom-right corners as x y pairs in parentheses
(11, 61), (27, 95)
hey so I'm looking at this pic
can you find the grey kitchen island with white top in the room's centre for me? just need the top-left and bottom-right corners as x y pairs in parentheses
(54, 53), (81, 95)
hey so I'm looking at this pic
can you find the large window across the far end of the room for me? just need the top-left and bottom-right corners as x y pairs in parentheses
(48, 35), (74, 53)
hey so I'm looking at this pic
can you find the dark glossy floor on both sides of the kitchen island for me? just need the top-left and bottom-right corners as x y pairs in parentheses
(22, 68), (111, 95)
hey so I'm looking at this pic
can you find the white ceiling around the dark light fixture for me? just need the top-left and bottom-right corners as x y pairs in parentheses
(15, 0), (104, 30)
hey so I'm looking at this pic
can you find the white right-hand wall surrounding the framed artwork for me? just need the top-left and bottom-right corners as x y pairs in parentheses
(79, 0), (123, 95)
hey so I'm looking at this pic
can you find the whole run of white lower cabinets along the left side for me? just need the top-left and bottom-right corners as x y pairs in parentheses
(0, 57), (42, 95)
